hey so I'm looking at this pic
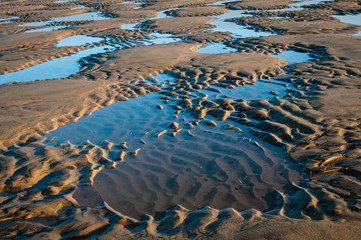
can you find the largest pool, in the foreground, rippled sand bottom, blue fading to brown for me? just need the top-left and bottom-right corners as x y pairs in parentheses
(47, 74), (300, 217)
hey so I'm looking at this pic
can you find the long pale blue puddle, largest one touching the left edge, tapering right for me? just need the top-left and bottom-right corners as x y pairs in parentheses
(0, 46), (113, 84)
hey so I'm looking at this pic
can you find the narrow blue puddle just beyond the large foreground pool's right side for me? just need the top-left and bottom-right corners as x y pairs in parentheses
(198, 80), (288, 101)
